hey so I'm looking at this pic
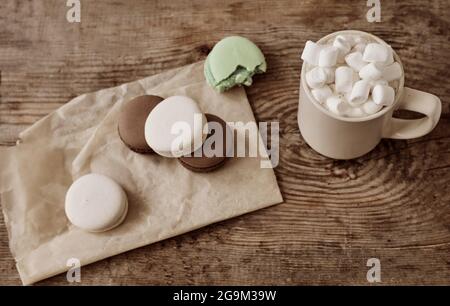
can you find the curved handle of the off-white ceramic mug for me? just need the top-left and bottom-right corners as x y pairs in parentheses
(383, 87), (442, 139)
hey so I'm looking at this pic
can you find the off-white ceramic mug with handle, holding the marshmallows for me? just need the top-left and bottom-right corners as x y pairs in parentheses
(298, 30), (441, 159)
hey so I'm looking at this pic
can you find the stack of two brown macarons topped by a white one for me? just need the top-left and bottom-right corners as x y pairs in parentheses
(118, 95), (231, 172)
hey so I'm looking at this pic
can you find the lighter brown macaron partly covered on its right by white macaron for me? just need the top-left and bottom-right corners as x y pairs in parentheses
(118, 95), (164, 153)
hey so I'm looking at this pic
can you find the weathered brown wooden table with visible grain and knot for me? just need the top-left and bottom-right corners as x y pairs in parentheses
(0, 0), (450, 285)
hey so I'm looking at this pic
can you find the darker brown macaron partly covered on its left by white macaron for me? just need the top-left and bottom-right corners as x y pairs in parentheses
(178, 114), (232, 172)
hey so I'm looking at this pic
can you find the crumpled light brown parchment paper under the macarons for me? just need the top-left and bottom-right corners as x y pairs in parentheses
(0, 62), (282, 284)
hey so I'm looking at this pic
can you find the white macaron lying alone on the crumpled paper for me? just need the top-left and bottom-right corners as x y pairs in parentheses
(65, 173), (128, 232)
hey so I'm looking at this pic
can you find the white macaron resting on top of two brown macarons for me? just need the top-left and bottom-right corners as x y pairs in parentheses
(145, 96), (207, 158)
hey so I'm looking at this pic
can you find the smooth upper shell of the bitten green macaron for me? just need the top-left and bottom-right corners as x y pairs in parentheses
(208, 36), (267, 84)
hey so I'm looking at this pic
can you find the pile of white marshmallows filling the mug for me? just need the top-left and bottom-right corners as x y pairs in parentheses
(301, 35), (403, 117)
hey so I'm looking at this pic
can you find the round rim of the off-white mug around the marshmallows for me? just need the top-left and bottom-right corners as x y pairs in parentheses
(300, 30), (405, 122)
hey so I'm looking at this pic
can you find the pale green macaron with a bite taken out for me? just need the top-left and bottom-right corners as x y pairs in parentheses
(204, 36), (267, 92)
